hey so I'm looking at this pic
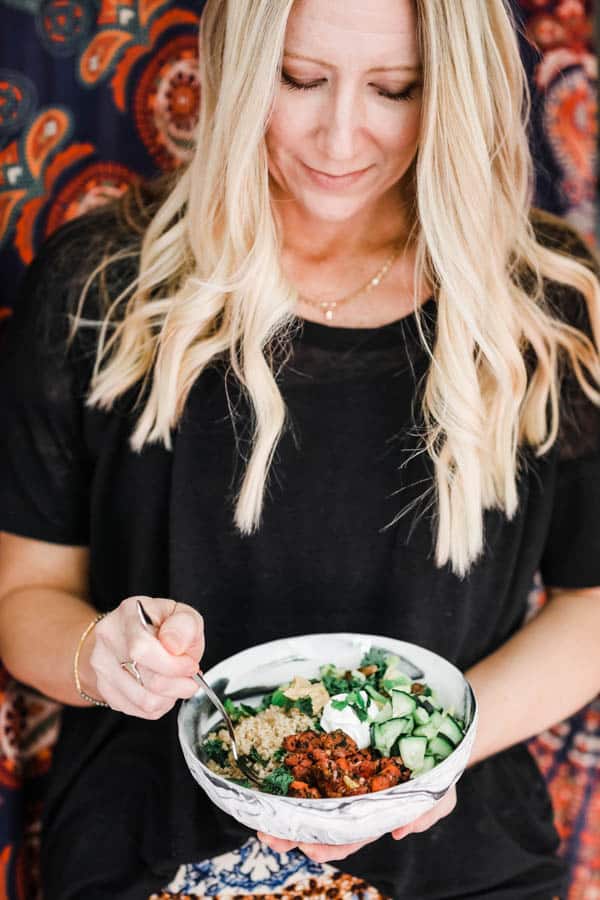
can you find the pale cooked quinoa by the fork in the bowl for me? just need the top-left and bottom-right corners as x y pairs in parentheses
(206, 706), (315, 778)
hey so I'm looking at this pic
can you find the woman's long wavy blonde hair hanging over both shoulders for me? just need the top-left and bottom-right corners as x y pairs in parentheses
(76, 0), (600, 576)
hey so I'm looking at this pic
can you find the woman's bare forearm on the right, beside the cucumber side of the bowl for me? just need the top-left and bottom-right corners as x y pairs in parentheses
(465, 587), (600, 765)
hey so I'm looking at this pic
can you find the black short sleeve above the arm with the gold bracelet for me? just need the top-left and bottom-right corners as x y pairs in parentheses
(0, 225), (96, 545)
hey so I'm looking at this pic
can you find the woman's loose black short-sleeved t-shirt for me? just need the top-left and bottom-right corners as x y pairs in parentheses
(0, 212), (600, 900)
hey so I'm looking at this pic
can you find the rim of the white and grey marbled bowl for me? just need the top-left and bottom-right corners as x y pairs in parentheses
(177, 631), (479, 809)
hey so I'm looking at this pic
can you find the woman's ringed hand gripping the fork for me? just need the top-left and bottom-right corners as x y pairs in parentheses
(80, 597), (204, 719)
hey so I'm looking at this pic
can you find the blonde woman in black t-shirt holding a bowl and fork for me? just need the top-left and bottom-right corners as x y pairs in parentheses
(0, 0), (600, 900)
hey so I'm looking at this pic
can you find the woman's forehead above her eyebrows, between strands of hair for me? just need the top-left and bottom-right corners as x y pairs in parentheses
(285, 0), (420, 69)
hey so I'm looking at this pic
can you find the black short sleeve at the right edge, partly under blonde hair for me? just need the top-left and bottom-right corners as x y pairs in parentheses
(540, 217), (600, 589)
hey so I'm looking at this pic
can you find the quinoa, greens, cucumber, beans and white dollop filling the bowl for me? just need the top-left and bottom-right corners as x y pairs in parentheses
(200, 648), (465, 800)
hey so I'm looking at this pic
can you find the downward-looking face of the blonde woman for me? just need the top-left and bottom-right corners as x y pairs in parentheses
(266, 0), (422, 222)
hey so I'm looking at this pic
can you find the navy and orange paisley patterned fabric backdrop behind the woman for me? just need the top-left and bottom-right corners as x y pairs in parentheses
(0, 0), (600, 900)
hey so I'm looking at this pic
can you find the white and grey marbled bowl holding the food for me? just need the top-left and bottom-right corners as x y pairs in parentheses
(178, 633), (477, 844)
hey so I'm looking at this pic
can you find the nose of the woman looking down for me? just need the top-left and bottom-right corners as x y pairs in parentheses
(319, 83), (364, 164)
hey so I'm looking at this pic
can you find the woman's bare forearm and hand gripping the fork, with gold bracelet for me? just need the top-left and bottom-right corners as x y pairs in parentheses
(0, 532), (204, 719)
